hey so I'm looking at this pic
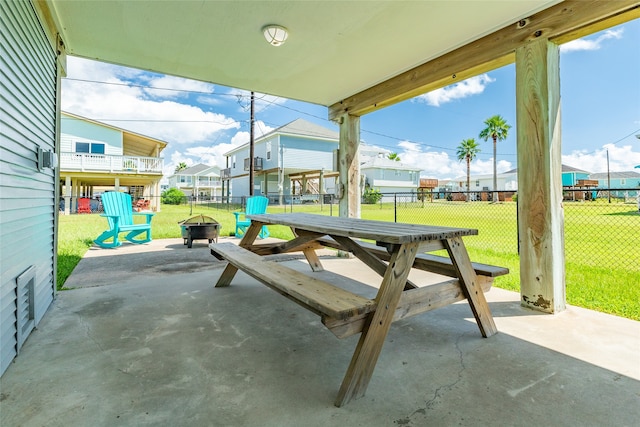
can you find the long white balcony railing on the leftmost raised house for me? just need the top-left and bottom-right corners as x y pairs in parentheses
(60, 153), (164, 174)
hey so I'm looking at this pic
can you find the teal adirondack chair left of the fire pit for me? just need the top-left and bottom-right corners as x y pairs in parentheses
(93, 191), (155, 248)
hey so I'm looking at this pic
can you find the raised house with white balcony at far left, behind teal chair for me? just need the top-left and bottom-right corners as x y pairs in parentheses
(60, 112), (167, 214)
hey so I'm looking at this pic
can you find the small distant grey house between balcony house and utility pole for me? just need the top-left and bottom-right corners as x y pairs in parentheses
(167, 163), (222, 200)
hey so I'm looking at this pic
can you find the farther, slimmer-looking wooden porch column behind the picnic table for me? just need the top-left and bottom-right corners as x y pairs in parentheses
(338, 114), (360, 218)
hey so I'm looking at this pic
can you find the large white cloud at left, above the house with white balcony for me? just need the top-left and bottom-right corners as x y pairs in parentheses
(62, 57), (240, 144)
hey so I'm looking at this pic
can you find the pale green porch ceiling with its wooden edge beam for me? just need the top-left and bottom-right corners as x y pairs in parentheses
(42, 0), (638, 118)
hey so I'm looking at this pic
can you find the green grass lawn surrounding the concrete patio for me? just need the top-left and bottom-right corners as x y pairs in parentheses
(58, 203), (640, 320)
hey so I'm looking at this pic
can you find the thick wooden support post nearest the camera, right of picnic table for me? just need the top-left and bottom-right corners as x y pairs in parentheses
(516, 40), (566, 313)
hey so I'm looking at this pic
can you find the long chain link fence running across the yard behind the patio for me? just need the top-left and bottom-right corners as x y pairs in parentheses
(60, 189), (640, 271)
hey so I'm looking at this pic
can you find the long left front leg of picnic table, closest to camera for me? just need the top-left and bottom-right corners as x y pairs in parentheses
(335, 243), (418, 407)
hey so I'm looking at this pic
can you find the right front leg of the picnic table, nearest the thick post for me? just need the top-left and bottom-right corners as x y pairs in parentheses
(445, 237), (498, 338)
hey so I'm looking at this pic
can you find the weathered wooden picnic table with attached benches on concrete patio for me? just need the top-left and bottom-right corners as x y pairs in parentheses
(210, 213), (500, 406)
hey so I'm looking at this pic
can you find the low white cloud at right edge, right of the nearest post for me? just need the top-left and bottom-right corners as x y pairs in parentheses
(562, 144), (640, 173)
